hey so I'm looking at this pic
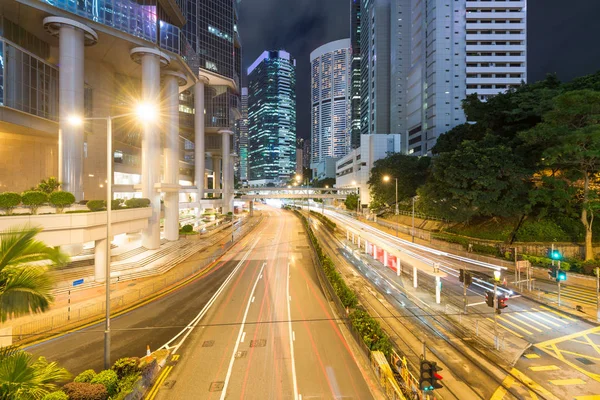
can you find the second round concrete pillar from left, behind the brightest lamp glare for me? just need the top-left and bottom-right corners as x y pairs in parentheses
(129, 47), (170, 250)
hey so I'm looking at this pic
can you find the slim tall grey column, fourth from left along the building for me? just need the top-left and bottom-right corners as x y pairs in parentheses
(194, 75), (208, 200)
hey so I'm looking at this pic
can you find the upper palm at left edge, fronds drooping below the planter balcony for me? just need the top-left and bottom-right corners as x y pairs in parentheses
(0, 227), (68, 322)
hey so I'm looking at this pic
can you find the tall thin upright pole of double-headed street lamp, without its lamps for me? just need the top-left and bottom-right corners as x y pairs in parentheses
(104, 117), (113, 369)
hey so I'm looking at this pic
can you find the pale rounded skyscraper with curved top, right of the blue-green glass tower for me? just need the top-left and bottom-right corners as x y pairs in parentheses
(310, 39), (352, 173)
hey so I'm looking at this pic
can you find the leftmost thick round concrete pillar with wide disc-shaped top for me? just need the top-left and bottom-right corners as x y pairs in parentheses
(44, 17), (98, 200)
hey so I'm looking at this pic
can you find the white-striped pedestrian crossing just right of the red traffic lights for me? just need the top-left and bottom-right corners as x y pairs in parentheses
(487, 306), (575, 338)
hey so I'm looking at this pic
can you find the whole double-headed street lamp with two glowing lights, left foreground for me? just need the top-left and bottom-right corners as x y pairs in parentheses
(67, 103), (157, 369)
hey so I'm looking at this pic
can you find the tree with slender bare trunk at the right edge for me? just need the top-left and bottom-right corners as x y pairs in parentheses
(521, 90), (600, 261)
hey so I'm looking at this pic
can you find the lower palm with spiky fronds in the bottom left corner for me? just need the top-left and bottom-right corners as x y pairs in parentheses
(0, 346), (70, 400)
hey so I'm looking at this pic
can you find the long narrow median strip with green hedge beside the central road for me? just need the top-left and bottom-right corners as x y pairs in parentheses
(294, 210), (412, 400)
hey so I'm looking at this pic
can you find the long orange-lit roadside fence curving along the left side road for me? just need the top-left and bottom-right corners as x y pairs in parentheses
(8, 216), (263, 343)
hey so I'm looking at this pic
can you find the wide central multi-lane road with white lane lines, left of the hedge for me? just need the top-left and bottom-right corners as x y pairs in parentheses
(149, 210), (373, 399)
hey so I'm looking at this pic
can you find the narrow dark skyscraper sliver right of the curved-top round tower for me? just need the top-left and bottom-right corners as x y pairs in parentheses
(350, 0), (361, 149)
